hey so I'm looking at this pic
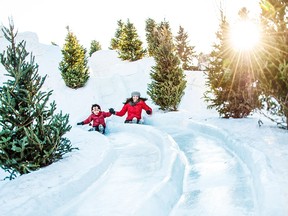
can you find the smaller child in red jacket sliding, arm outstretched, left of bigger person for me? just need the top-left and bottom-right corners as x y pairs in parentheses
(77, 104), (111, 134)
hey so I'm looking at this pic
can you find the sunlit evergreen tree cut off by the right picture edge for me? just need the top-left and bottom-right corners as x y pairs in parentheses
(259, 0), (288, 129)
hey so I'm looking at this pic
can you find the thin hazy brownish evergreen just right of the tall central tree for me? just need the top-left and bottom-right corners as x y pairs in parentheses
(175, 26), (196, 70)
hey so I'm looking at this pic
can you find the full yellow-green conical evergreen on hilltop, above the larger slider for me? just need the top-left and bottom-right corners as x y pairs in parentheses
(117, 19), (146, 61)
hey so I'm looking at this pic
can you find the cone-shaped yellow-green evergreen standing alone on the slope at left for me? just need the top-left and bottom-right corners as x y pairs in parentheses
(59, 27), (89, 89)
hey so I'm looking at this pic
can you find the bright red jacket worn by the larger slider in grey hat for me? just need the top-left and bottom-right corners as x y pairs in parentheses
(115, 100), (152, 121)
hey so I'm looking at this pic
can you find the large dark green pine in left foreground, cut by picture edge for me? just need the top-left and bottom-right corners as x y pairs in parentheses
(0, 21), (73, 179)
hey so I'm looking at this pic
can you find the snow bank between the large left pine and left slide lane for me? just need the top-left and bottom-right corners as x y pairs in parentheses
(0, 128), (115, 216)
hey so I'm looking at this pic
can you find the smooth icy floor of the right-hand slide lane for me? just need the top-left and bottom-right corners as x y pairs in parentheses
(165, 125), (254, 216)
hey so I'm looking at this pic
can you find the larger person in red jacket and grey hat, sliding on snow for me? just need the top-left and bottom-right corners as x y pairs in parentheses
(109, 91), (152, 124)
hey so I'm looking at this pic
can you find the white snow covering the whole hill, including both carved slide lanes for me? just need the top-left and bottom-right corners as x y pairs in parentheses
(0, 33), (288, 216)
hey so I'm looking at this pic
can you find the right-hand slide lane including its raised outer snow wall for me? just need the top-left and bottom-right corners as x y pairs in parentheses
(162, 121), (268, 216)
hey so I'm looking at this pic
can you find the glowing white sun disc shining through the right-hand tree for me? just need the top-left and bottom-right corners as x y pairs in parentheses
(230, 20), (260, 51)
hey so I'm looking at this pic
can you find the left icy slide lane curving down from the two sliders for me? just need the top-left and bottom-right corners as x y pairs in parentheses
(53, 123), (185, 216)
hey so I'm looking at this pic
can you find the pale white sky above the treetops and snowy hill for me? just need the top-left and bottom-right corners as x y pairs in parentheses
(0, 0), (258, 52)
